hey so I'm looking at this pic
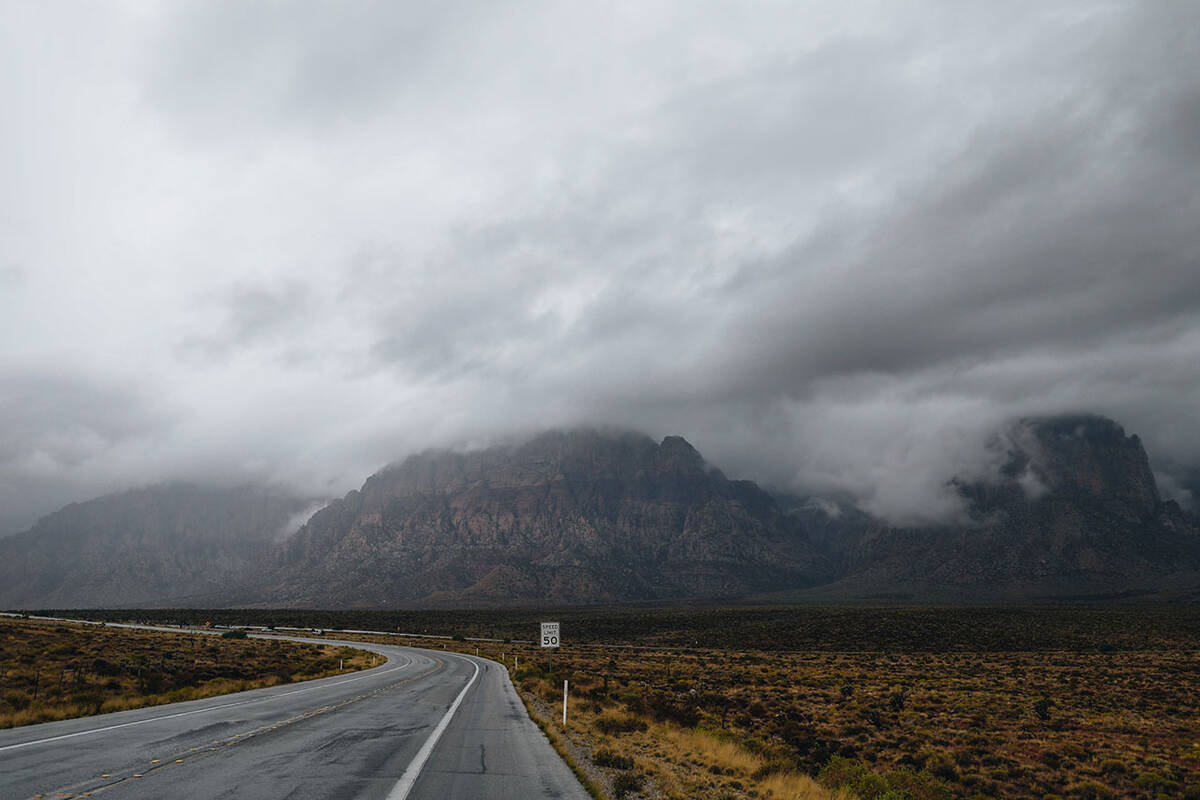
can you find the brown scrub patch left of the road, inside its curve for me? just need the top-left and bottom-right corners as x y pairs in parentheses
(0, 618), (372, 728)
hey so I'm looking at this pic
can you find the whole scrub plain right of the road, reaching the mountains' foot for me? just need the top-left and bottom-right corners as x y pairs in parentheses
(23, 606), (1200, 800)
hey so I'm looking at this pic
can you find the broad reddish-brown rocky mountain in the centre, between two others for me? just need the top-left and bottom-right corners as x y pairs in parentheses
(263, 431), (828, 606)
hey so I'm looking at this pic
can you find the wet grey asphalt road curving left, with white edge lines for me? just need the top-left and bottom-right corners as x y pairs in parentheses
(0, 637), (589, 800)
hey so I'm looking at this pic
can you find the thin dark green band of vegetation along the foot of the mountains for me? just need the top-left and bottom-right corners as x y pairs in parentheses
(23, 604), (1200, 652)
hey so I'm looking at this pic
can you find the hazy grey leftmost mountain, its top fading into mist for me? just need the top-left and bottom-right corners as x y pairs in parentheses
(0, 483), (311, 608)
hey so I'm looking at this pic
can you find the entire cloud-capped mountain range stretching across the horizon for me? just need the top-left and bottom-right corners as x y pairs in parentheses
(0, 415), (1200, 608)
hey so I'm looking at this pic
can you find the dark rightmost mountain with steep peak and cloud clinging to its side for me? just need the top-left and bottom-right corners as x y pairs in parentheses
(792, 415), (1200, 600)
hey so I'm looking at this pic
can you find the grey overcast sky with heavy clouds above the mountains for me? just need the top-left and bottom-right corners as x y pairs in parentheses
(0, 0), (1200, 531)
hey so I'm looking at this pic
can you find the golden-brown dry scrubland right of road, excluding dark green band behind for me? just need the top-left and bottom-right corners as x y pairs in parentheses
(324, 640), (1200, 800)
